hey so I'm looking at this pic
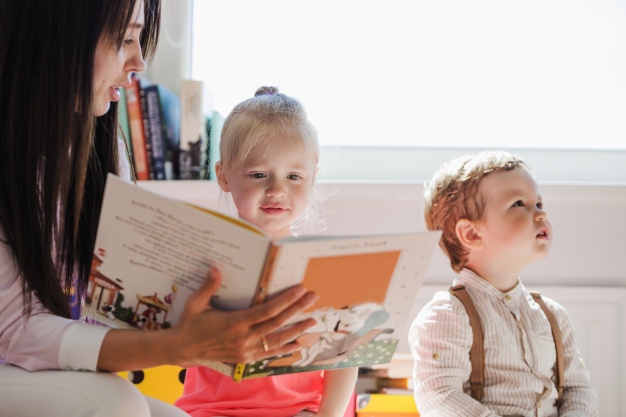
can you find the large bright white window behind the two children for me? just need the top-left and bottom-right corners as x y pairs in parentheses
(191, 0), (626, 182)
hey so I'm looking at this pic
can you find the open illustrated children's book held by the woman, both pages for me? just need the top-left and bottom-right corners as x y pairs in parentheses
(83, 175), (440, 380)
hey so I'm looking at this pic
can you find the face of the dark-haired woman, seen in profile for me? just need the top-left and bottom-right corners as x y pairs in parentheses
(93, 0), (146, 116)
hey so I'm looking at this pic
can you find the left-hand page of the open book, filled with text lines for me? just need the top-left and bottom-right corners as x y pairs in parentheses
(84, 175), (269, 328)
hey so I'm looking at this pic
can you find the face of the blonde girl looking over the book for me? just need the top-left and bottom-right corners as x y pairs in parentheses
(216, 141), (317, 240)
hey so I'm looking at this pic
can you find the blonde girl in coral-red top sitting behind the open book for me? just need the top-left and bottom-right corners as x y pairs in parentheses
(176, 87), (357, 417)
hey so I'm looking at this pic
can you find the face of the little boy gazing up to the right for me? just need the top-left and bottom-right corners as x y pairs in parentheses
(476, 168), (552, 272)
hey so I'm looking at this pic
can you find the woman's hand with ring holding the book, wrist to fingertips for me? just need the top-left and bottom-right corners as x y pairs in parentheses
(172, 268), (317, 367)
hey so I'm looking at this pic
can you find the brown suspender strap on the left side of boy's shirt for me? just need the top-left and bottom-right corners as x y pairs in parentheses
(450, 285), (485, 401)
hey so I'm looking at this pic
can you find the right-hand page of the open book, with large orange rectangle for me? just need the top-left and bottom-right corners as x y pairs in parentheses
(233, 232), (440, 378)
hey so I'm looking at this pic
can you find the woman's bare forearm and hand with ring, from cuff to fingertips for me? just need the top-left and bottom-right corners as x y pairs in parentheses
(98, 268), (317, 372)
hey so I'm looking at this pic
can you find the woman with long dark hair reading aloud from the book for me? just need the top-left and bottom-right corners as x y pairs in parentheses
(0, 0), (315, 416)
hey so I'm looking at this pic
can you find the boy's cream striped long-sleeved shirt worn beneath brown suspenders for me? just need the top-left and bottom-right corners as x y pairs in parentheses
(409, 269), (598, 417)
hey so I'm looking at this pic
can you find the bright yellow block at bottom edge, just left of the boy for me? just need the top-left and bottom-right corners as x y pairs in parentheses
(356, 394), (419, 417)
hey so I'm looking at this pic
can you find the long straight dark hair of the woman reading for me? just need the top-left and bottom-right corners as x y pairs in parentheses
(0, 0), (161, 317)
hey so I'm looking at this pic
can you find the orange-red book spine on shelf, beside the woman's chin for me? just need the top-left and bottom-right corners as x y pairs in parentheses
(126, 77), (150, 180)
